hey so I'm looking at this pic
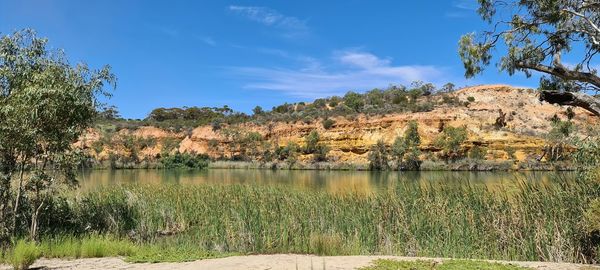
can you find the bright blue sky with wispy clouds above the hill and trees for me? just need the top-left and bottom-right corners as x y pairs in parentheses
(0, 0), (537, 118)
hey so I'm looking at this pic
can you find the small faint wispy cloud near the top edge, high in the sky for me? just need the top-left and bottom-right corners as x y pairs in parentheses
(229, 6), (309, 38)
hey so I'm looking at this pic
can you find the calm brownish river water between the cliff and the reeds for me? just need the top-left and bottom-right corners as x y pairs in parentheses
(79, 169), (574, 193)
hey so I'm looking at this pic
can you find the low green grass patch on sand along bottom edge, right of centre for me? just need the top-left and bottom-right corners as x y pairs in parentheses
(360, 260), (526, 270)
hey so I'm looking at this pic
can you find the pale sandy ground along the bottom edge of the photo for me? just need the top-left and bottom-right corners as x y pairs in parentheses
(0, 254), (600, 270)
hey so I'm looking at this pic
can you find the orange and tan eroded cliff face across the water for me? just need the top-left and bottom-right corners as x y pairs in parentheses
(85, 85), (598, 163)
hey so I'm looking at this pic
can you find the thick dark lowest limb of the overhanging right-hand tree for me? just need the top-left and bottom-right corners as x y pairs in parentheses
(540, 90), (600, 117)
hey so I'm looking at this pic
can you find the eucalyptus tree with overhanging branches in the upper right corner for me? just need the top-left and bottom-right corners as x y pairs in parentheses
(459, 0), (600, 116)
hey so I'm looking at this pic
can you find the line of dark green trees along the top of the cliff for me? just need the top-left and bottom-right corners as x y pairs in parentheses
(98, 81), (474, 130)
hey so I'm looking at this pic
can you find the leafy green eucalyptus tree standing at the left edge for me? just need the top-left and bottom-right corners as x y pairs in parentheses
(0, 29), (116, 240)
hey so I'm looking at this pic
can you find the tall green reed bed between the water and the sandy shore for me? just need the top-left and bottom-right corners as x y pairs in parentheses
(3, 174), (600, 262)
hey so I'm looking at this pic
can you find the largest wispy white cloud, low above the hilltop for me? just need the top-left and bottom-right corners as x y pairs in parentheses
(229, 50), (448, 98)
